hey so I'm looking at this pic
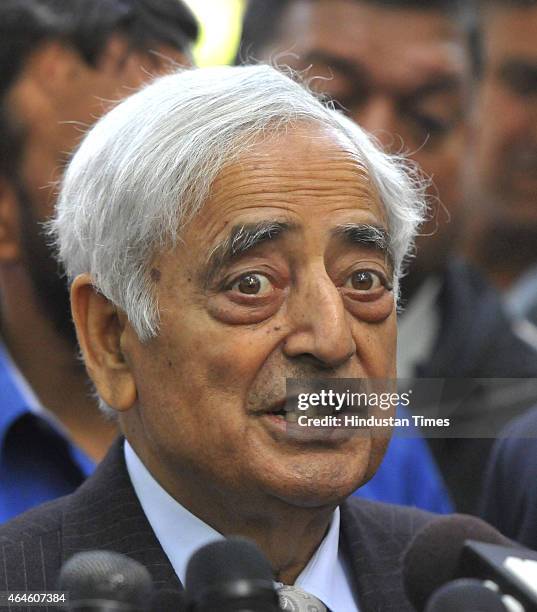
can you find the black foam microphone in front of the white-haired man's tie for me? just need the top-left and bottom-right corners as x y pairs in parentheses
(185, 537), (280, 612)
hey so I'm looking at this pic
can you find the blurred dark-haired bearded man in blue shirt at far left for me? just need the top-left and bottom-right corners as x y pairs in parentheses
(0, 0), (198, 521)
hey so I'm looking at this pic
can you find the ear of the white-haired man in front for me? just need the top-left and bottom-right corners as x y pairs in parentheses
(71, 274), (137, 412)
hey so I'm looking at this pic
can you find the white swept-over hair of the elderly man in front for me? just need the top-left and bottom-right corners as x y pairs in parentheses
(49, 65), (426, 341)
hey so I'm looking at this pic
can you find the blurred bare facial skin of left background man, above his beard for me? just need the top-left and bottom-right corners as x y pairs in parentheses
(9, 42), (189, 225)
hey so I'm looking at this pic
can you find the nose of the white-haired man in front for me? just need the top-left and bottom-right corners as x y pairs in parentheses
(283, 274), (356, 368)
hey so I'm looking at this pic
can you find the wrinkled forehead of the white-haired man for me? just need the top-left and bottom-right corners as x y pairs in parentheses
(184, 126), (385, 246)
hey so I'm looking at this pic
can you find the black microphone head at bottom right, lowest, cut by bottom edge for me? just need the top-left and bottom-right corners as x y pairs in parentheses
(425, 578), (507, 612)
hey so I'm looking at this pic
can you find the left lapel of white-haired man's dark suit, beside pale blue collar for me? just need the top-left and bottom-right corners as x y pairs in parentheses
(58, 439), (182, 589)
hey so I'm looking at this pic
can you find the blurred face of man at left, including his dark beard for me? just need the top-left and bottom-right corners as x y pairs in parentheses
(6, 36), (188, 341)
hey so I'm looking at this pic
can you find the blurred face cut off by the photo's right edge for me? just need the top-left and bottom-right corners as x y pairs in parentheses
(476, 3), (537, 231)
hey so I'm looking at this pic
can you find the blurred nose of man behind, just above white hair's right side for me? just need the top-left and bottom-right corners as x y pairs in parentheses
(352, 95), (401, 152)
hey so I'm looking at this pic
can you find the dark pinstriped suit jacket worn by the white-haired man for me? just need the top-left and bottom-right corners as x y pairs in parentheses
(0, 440), (434, 612)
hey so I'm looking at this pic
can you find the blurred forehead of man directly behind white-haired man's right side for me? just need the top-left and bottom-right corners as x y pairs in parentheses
(280, 0), (469, 90)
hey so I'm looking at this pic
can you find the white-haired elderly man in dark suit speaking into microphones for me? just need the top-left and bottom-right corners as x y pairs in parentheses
(0, 66), (432, 612)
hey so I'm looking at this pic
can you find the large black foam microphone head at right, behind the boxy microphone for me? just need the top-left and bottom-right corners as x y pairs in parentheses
(403, 514), (512, 612)
